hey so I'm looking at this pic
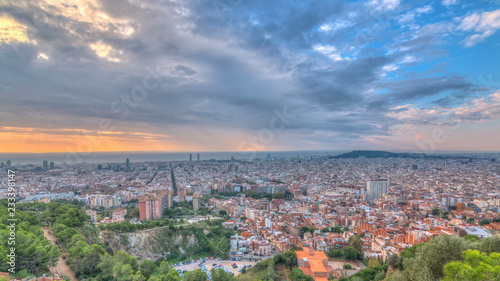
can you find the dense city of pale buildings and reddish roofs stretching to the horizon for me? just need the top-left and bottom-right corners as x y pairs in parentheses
(0, 151), (500, 280)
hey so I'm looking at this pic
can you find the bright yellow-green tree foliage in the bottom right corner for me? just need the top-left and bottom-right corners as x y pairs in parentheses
(443, 250), (500, 281)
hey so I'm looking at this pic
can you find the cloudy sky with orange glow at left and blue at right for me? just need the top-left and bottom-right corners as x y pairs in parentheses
(0, 0), (500, 154)
